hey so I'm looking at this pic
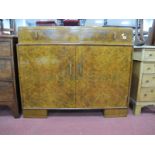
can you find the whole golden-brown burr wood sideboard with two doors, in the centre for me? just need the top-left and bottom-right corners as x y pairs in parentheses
(17, 26), (133, 117)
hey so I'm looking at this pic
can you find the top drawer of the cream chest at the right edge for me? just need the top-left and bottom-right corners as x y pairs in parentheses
(144, 49), (155, 61)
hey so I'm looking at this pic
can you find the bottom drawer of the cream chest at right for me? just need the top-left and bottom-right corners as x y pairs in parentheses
(139, 88), (155, 101)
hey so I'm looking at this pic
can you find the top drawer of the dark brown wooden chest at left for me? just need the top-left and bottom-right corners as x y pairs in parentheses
(0, 41), (11, 57)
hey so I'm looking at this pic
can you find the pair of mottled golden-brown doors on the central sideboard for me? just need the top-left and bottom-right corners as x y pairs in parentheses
(18, 44), (132, 109)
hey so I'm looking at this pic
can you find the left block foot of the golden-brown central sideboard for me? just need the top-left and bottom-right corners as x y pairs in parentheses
(23, 109), (47, 118)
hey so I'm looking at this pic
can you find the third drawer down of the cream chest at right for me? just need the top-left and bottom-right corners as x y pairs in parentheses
(142, 74), (155, 87)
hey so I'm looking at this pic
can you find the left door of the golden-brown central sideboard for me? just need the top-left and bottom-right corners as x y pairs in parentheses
(18, 45), (75, 109)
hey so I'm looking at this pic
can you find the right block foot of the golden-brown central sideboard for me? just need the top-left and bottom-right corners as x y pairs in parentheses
(103, 108), (128, 117)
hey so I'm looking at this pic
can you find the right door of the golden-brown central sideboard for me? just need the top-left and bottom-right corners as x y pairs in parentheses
(76, 46), (132, 108)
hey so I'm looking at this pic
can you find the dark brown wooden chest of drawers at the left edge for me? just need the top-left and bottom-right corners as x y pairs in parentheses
(0, 35), (19, 117)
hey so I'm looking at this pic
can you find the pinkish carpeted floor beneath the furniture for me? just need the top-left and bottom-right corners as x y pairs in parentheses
(0, 108), (155, 135)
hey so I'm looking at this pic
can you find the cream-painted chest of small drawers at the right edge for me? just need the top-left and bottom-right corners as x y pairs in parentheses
(131, 46), (155, 115)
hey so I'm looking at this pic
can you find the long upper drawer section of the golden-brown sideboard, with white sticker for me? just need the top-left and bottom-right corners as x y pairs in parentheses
(18, 26), (132, 45)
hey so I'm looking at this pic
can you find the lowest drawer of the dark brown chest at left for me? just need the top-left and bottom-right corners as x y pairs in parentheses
(0, 82), (14, 101)
